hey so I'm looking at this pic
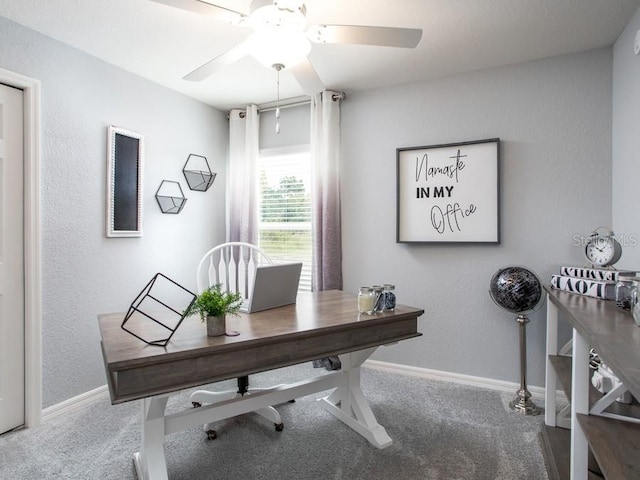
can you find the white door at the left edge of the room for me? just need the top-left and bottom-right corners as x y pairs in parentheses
(0, 84), (25, 433)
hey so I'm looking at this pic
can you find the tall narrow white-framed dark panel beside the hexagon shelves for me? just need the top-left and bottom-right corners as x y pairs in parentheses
(107, 125), (144, 237)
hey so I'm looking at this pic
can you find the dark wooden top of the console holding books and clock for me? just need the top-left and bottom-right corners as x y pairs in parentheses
(545, 286), (640, 398)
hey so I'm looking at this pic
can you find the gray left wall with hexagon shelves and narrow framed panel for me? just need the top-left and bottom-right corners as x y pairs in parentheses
(0, 17), (228, 407)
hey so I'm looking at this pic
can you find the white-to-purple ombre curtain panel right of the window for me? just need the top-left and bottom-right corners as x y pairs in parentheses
(311, 91), (342, 291)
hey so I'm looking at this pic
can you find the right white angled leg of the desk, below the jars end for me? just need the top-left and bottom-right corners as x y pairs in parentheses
(321, 347), (392, 448)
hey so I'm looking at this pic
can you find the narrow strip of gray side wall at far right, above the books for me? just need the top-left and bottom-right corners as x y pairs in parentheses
(613, 9), (640, 264)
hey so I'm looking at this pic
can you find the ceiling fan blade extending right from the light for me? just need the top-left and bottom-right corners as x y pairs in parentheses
(309, 25), (422, 48)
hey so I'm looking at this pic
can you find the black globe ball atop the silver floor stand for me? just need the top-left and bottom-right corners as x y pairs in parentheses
(489, 267), (542, 314)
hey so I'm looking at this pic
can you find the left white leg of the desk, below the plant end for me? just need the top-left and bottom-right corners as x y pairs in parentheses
(133, 395), (169, 480)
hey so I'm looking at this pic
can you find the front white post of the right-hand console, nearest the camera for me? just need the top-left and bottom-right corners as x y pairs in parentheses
(571, 328), (589, 480)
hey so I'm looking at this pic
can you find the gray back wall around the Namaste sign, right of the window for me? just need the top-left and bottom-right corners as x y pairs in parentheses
(342, 49), (612, 386)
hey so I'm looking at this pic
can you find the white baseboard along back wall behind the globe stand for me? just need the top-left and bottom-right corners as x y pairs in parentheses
(363, 360), (567, 405)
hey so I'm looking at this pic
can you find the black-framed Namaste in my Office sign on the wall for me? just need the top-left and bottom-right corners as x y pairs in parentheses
(396, 138), (500, 243)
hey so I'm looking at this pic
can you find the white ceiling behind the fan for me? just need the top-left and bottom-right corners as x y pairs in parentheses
(0, 0), (640, 110)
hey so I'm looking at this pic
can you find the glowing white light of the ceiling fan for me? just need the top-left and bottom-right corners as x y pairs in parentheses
(247, 29), (311, 69)
